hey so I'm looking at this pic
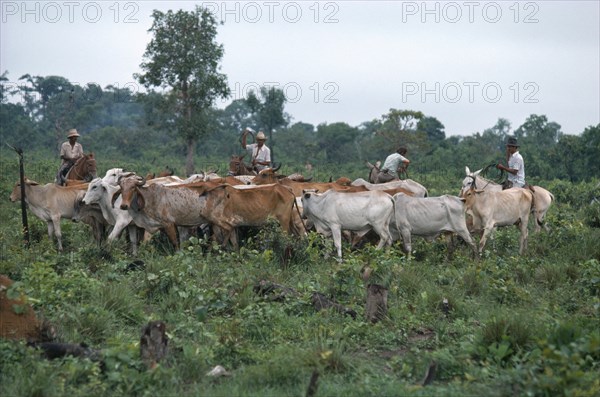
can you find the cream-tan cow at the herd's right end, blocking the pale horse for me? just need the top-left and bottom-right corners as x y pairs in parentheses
(461, 187), (533, 254)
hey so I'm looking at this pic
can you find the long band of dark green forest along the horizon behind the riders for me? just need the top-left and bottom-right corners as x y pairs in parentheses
(0, 72), (600, 182)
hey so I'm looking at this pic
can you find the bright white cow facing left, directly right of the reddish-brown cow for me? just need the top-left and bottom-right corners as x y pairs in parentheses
(302, 189), (394, 258)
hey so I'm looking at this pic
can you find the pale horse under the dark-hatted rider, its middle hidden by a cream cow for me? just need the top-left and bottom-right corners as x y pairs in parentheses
(459, 167), (554, 233)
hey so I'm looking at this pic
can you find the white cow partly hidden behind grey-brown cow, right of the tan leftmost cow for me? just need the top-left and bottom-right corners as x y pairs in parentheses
(83, 178), (138, 255)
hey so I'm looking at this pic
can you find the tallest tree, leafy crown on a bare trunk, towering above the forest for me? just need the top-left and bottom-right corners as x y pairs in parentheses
(135, 6), (230, 174)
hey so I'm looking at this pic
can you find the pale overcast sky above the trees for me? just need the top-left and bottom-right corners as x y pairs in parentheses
(0, 0), (600, 136)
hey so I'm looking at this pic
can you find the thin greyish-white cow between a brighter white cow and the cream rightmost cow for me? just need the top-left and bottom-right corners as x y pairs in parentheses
(390, 193), (477, 254)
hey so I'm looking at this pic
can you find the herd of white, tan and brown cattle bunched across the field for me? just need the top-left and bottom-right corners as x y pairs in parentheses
(10, 163), (554, 259)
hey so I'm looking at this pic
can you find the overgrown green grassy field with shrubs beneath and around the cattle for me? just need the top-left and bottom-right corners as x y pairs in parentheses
(0, 159), (600, 397)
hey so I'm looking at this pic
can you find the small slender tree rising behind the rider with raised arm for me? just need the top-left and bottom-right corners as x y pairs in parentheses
(246, 87), (289, 161)
